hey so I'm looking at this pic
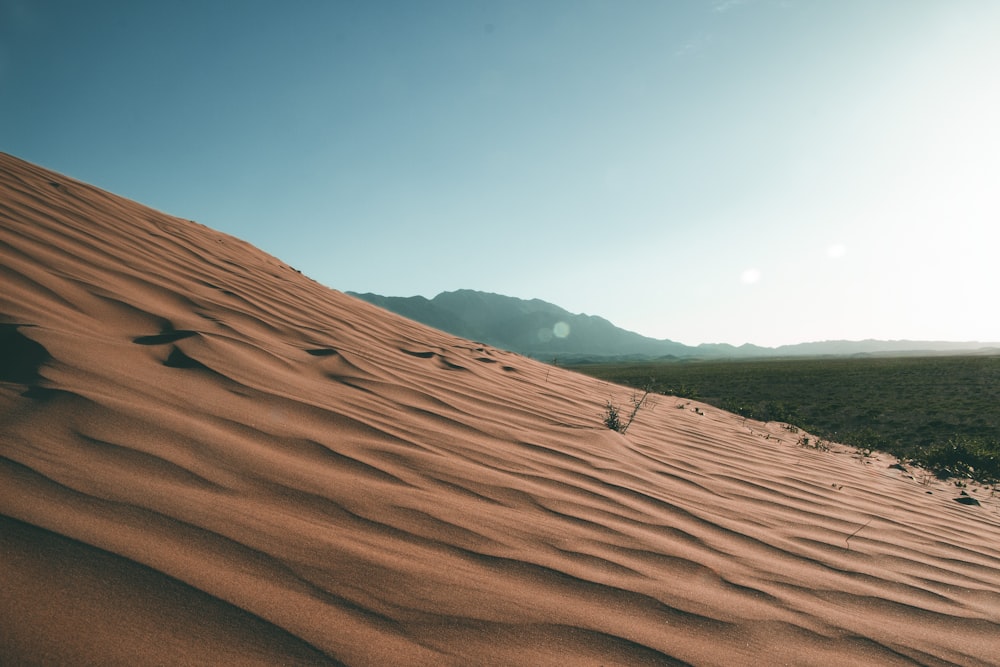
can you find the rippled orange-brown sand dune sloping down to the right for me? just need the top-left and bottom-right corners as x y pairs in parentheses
(0, 154), (1000, 665)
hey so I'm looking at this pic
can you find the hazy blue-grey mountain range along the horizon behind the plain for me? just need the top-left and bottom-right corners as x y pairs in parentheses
(348, 290), (1000, 361)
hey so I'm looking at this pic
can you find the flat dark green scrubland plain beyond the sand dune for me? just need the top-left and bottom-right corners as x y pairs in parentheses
(569, 356), (1000, 483)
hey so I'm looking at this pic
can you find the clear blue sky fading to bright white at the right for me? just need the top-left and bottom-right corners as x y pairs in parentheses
(0, 0), (1000, 346)
